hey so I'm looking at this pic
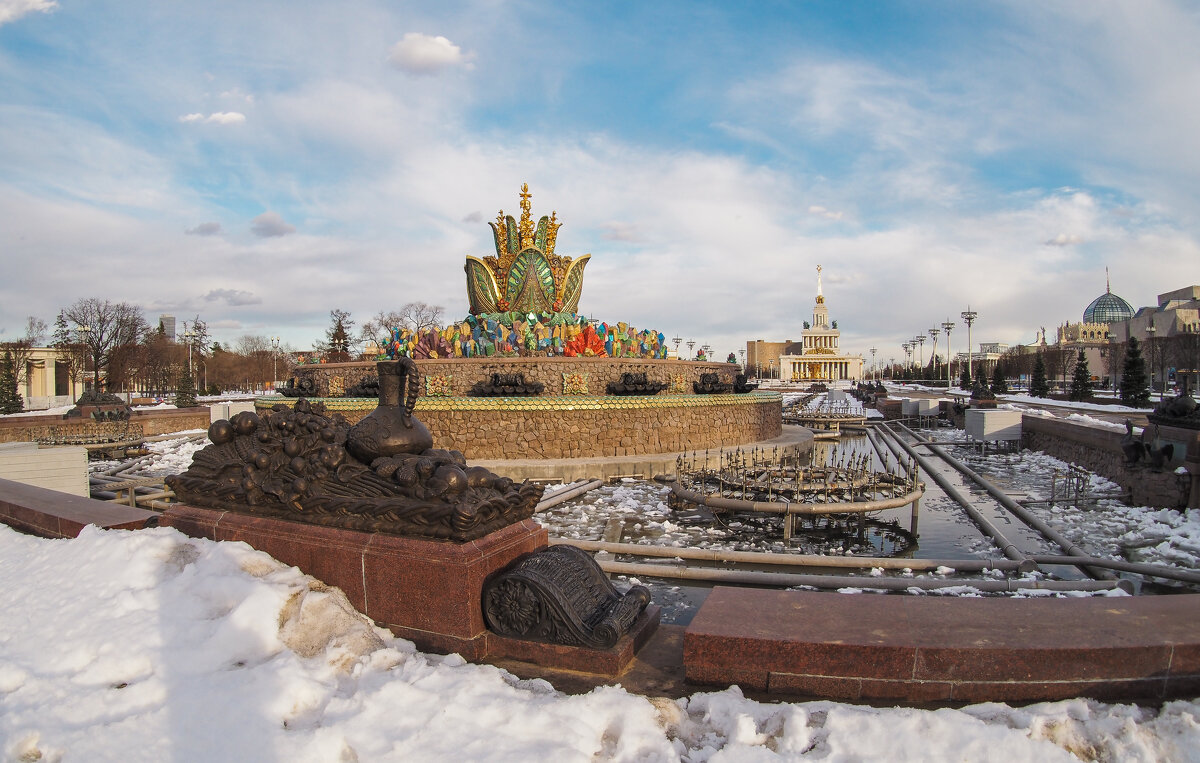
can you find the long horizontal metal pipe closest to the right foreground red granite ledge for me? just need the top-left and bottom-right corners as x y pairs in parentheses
(596, 559), (1133, 593)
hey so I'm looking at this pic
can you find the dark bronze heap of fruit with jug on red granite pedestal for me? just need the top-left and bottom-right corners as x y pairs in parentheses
(167, 358), (545, 541)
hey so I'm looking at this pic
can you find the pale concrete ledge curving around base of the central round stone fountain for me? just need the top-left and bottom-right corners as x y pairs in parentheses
(470, 425), (814, 482)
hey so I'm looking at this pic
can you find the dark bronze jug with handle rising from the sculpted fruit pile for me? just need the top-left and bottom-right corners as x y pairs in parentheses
(346, 358), (433, 464)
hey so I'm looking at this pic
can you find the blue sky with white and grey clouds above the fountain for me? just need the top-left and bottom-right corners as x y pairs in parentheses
(0, 0), (1200, 361)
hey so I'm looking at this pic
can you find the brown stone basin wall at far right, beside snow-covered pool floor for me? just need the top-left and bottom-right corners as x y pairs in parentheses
(1021, 416), (1196, 509)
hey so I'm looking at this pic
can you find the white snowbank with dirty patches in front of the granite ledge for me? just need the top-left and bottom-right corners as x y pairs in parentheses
(0, 527), (1200, 763)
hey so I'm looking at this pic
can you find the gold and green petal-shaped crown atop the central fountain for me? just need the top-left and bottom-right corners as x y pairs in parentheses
(464, 184), (592, 316)
